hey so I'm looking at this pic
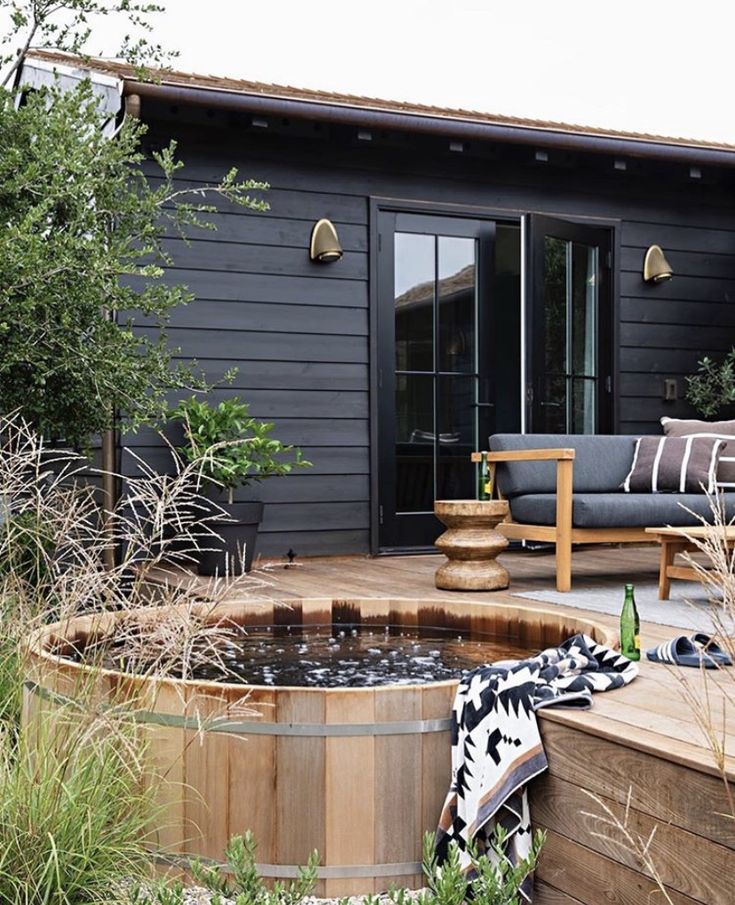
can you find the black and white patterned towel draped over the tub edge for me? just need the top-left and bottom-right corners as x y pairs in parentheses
(436, 635), (638, 902)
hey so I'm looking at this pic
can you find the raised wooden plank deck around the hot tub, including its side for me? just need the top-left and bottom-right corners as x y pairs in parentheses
(242, 547), (735, 905)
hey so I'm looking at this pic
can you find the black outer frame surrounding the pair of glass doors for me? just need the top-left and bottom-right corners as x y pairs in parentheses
(368, 196), (621, 555)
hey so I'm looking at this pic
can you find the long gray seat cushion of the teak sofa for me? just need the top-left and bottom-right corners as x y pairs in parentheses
(510, 493), (735, 528)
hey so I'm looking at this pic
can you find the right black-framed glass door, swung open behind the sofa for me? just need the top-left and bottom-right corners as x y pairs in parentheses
(528, 215), (613, 434)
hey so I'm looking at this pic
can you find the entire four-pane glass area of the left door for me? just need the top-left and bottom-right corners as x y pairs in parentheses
(394, 232), (479, 513)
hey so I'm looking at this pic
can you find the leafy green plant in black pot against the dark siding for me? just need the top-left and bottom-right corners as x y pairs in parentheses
(170, 396), (311, 575)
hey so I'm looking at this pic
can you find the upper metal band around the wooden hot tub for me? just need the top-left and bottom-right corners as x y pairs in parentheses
(25, 682), (452, 738)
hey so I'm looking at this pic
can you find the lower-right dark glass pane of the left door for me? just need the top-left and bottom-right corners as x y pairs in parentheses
(436, 377), (476, 500)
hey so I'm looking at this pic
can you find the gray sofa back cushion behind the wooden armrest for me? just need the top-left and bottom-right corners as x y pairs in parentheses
(490, 434), (640, 498)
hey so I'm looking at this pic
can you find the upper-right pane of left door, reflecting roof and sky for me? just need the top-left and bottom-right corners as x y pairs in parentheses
(437, 236), (477, 373)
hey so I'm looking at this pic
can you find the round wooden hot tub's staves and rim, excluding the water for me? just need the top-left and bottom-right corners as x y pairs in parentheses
(24, 598), (617, 896)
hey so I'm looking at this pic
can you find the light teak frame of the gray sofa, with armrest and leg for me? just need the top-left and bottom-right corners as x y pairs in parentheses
(472, 449), (651, 591)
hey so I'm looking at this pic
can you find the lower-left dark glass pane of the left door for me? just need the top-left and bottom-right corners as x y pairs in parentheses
(396, 374), (434, 512)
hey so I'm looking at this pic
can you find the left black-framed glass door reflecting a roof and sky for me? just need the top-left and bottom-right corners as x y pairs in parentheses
(379, 214), (520, 549)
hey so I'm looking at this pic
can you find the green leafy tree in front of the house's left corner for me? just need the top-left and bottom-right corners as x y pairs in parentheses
(0, 0), (268, 446)
